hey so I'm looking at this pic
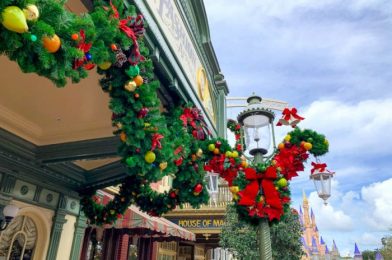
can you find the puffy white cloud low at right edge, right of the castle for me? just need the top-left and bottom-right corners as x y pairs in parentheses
(361, 178), (392, 230)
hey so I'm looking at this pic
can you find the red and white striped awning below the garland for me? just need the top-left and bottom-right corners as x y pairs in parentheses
(102, 192), (196, 241)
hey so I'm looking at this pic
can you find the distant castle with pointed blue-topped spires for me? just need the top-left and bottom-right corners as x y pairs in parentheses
(299, 192), (340, 260)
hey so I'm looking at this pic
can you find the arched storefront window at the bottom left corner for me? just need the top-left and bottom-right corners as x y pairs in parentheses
(0, 216), (37, 260)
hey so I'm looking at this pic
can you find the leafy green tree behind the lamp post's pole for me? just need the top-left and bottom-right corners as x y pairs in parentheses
(220, 206), (303, 260)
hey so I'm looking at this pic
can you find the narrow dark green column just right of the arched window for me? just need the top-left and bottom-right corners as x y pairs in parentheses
(46, 195), (67, 260)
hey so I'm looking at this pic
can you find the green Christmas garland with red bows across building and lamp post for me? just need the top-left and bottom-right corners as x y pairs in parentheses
(0, 0), (328, 225)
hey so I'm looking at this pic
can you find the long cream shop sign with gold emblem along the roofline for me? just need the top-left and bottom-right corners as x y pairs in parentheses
(146, 0), (215, 123)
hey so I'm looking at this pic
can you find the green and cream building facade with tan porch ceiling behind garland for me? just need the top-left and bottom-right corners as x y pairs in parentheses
(0, 0), (228, 260)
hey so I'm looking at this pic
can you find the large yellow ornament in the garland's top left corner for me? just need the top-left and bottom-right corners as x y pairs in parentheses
(1, 6), (29, 33)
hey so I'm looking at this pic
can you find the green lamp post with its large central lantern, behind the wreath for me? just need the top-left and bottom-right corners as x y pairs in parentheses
(237, 95), (275, 260)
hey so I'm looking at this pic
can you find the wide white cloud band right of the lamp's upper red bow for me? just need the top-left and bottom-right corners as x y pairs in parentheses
(300, 98), (392, 156)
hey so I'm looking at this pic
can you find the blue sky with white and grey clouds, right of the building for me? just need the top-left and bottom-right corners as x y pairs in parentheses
(204, 0), (392, 255)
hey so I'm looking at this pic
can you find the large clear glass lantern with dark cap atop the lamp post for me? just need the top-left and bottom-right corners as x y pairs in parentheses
(237, 96), (275, 156)
